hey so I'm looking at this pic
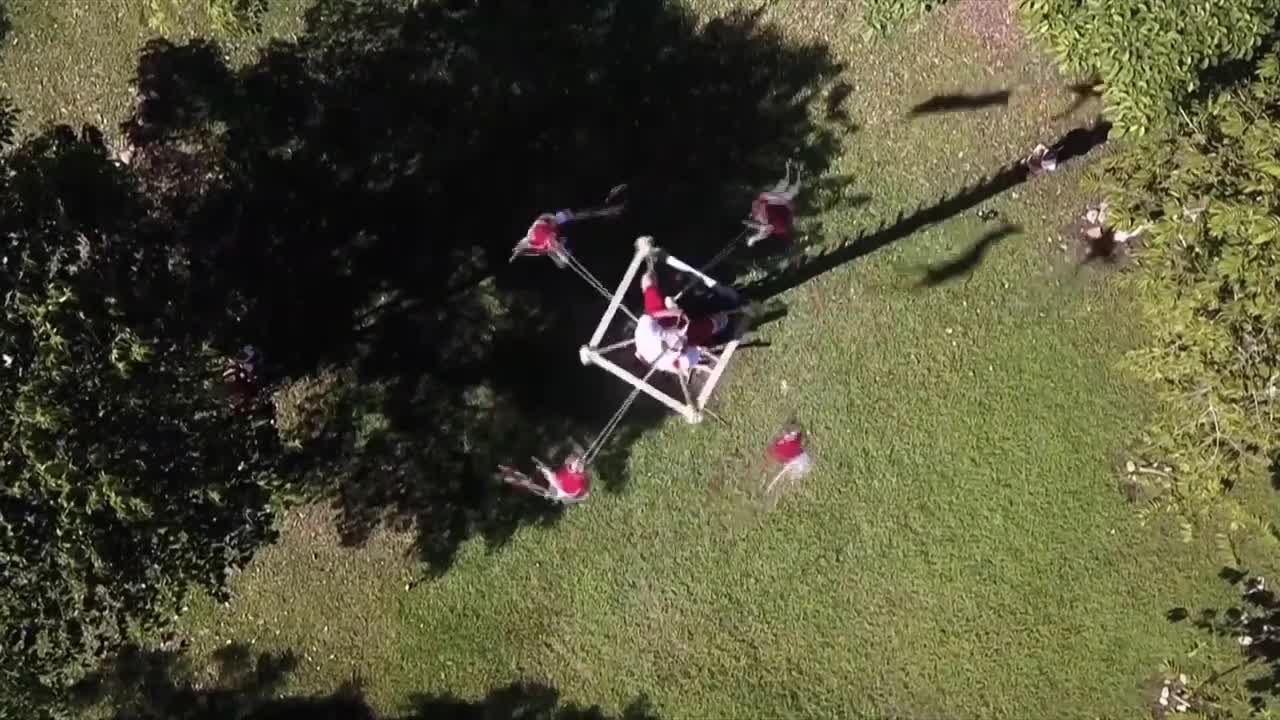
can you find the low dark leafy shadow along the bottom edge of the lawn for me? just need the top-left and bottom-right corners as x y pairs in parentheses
(73, 643), (659, 720)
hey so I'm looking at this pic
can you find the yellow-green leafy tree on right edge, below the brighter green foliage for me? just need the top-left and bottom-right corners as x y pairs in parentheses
(1097, 55), (1280, 561)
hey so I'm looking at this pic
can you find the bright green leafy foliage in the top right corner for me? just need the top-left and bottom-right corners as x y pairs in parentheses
(1018, 0), (1280, 136)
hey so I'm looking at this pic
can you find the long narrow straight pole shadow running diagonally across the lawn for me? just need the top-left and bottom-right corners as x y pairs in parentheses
(744, 120), (1111, 300)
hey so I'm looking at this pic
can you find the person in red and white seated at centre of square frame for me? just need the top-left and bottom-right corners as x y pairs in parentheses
(635, 273), (728, 375)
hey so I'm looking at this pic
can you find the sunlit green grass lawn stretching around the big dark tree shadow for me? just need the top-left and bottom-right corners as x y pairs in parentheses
(0, 0), (1239, 719)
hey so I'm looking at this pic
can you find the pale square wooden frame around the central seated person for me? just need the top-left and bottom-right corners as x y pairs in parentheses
(579, 236), (741, 423)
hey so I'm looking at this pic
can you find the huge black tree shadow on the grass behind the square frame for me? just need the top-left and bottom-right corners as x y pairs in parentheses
(117, 0), (840, 570)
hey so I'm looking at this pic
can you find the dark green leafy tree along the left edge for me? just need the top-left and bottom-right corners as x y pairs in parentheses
(0, 127), (282, 715)
